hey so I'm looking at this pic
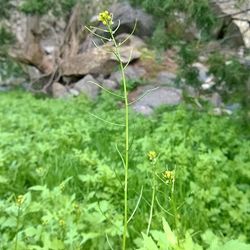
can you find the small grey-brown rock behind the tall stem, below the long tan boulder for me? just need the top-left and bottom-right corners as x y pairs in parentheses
(110, 65), (146, 85)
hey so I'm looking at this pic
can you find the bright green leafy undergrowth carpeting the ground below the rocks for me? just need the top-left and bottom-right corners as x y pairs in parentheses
(0, 92), (250, 250)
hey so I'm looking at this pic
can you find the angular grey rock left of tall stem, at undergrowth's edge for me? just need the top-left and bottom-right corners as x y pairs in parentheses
(74, 75), (101, 100)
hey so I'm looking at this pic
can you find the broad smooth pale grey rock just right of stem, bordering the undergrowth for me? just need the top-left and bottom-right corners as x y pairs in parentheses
(132, 85), (182, 114)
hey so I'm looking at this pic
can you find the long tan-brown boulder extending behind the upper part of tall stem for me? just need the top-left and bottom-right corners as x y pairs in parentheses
(61, 45), (141, 76)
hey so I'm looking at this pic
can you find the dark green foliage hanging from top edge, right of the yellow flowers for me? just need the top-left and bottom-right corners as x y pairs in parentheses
(130, 0), (216, 49)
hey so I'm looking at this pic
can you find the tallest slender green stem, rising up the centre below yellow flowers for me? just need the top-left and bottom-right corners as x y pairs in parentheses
(108, 24), (129, 250)
